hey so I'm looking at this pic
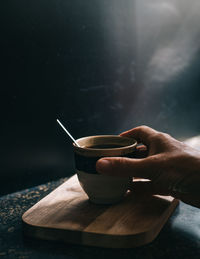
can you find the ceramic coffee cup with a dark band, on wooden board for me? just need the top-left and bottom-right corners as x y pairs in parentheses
(73, 135), (137, 204)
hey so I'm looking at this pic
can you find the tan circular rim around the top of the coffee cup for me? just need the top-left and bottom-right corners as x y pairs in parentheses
(73, 135), (137, 151)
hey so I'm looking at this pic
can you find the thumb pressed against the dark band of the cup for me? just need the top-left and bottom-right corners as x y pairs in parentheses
(96, 155), (162, 179)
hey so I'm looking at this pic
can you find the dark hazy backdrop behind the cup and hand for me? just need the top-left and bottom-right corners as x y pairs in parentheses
(0, 0), (200, 194)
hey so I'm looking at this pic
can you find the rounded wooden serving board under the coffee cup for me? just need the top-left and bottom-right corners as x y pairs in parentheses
(22, 175), (178, 248)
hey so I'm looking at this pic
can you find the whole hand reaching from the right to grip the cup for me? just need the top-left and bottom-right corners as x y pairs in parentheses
(96, 126), (200, 208)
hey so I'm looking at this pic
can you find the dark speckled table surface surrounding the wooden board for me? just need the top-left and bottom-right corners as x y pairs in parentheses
(0, 179), (200, 259)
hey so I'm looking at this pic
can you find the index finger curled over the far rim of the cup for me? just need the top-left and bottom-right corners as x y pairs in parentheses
(120, 126), (158, 146)
